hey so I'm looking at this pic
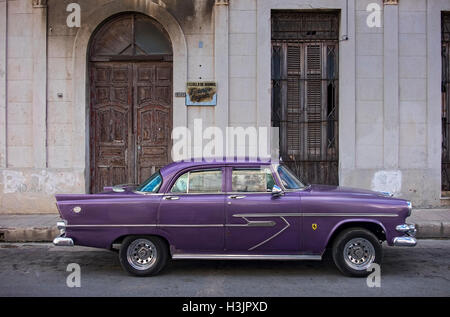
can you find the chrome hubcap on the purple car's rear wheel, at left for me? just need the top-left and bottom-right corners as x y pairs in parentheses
(127, 239), (158, 270)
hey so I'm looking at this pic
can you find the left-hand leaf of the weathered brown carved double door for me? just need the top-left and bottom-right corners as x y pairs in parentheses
(90, 63), (134, 192)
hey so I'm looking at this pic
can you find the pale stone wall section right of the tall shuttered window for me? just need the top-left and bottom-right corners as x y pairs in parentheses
(341, 0), (444, 206)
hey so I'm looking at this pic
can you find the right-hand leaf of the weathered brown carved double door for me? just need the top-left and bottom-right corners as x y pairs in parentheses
(133, 62), (172, 183)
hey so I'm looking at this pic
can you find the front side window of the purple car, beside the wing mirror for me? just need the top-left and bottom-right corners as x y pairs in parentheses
(231, 168), (275, 192)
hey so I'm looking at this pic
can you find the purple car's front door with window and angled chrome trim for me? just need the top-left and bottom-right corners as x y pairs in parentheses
(225, 165), (302, 254)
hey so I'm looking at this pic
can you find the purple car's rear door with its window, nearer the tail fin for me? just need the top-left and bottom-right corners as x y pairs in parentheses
(158, 167), (225, 254)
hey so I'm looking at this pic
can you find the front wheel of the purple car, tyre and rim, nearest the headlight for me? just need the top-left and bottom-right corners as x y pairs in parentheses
(332, 228), (382, 277)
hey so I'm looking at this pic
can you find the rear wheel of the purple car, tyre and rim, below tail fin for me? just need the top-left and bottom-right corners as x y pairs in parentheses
(119, 236), (169, 276)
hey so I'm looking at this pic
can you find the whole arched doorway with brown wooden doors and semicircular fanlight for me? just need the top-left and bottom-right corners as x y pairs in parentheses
(88, 13), (173, 192)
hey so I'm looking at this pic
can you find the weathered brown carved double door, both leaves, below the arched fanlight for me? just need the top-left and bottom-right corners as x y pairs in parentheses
(89, 62), (172, 193)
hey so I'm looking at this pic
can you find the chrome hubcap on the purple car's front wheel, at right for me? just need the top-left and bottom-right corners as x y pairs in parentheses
(344, 238), (375, 271)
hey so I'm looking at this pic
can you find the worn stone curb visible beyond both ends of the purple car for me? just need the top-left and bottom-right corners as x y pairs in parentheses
(0, 221), (450, 242)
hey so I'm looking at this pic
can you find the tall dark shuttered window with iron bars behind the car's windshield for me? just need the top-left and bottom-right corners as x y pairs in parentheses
(272, 10), (339, 184)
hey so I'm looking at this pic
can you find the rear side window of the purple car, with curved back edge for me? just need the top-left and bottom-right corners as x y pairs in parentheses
(170, 169), (222, 193)
